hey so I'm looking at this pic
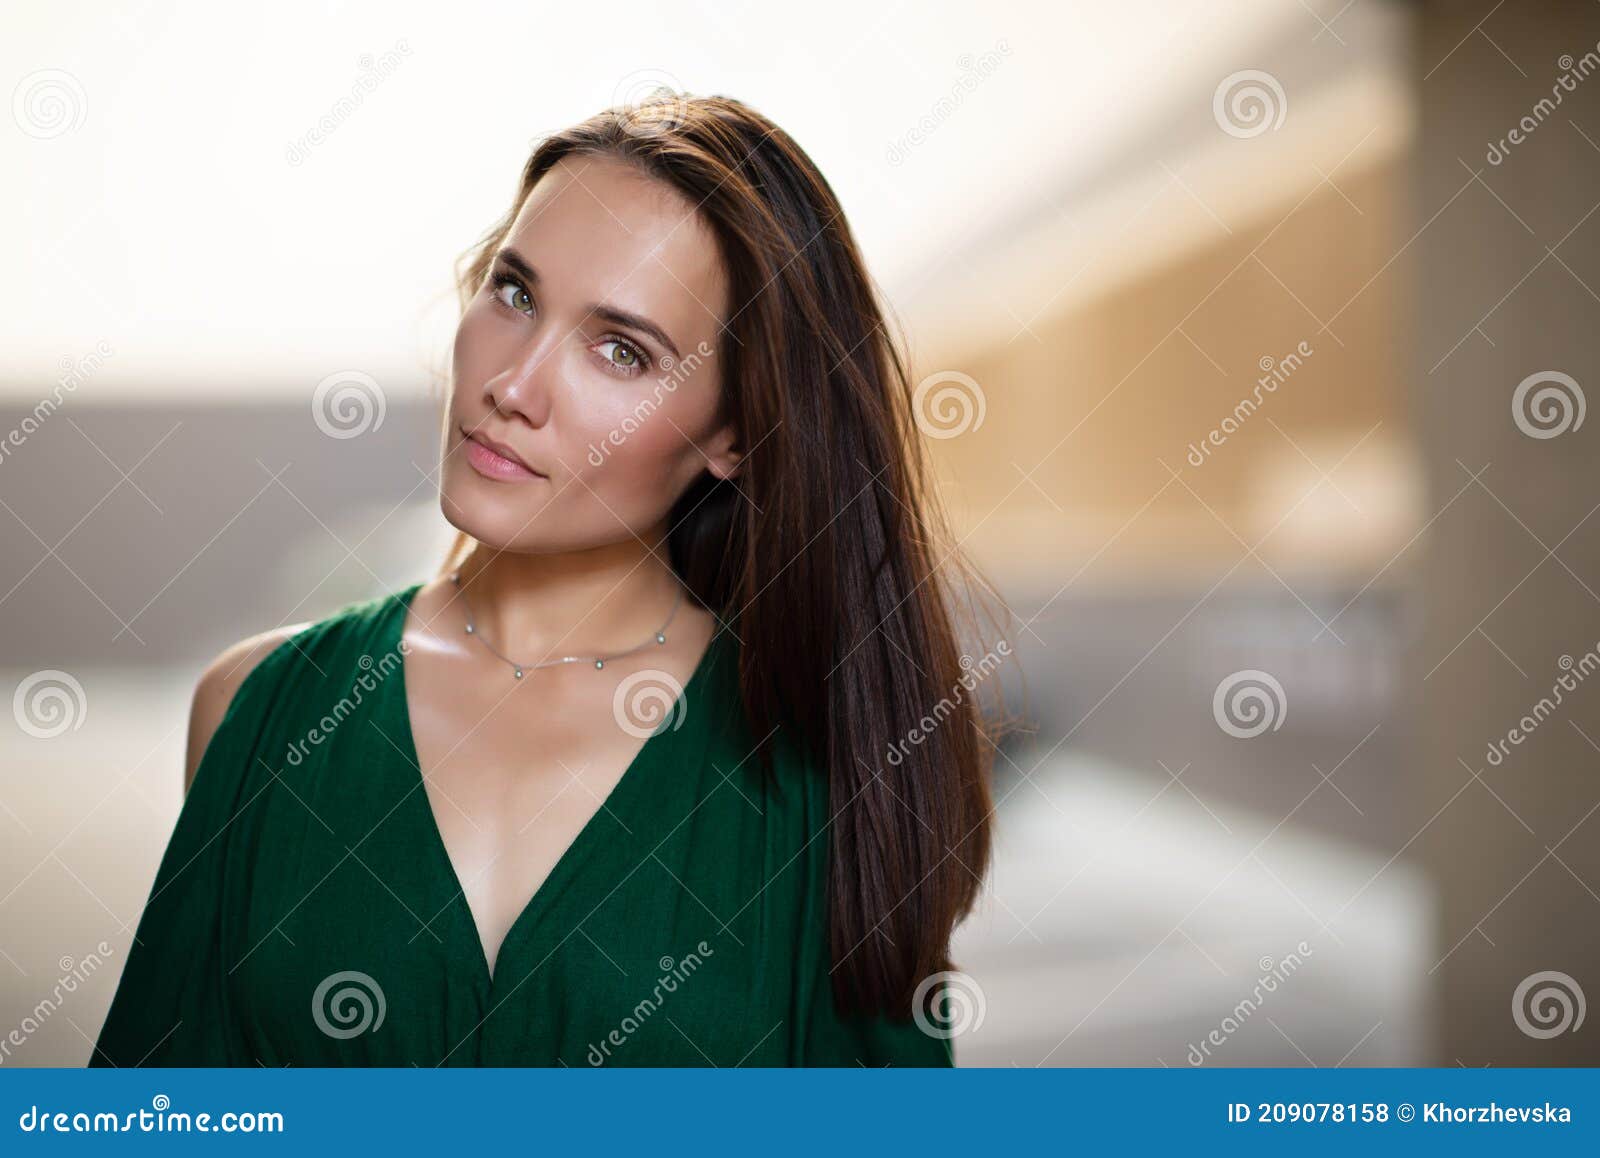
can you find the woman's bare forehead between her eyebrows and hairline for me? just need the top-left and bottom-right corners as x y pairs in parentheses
(506, 157), (726, 332)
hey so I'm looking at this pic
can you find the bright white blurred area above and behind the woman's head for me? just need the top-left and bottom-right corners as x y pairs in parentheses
(0, 0), (1366, 400)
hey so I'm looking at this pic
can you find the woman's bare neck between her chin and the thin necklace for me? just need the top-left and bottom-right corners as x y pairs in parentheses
(456, 534), (686, 664)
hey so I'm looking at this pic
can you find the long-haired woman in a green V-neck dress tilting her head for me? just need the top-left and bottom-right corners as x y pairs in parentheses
(91, 94), (992, 1065)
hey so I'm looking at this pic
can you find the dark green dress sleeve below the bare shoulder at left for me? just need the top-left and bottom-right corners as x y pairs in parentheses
(88, 656), (286, 1068)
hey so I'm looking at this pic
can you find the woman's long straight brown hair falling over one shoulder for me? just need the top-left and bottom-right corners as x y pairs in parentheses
(443, 91), (1005, 1019)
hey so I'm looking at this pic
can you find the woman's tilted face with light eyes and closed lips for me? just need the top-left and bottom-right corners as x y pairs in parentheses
(440, 157), (739, 552)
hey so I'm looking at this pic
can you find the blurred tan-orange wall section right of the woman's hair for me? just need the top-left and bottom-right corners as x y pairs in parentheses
(917, 160), (1418, 585)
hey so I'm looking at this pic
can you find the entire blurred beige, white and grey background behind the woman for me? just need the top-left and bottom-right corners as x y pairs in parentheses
(0, 0), (1600, 1067)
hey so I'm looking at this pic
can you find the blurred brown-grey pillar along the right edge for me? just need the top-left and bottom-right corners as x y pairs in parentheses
(1408, 0), (1600, 1065)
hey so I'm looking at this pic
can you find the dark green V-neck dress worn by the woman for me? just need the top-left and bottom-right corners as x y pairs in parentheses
(90, 584), (954, 1067)
